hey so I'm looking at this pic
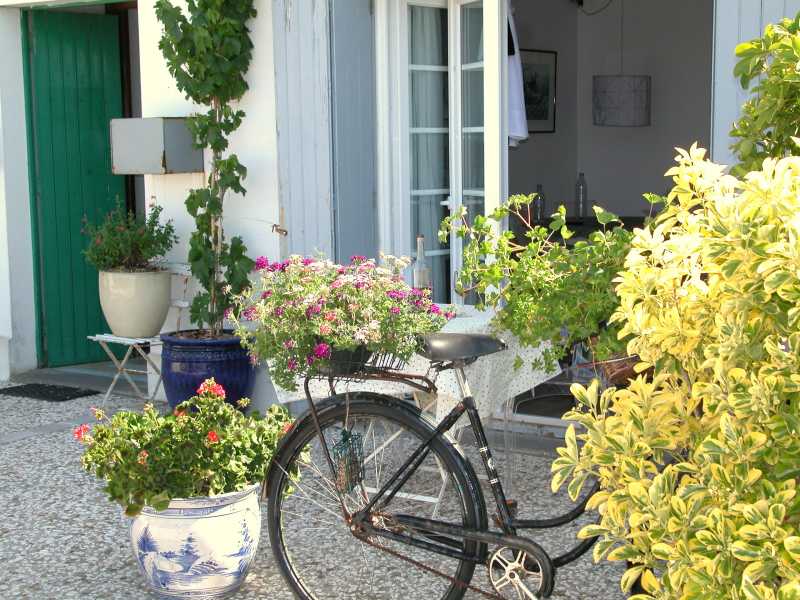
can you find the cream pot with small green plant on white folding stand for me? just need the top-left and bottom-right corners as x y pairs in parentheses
(83, 202), (178, 338)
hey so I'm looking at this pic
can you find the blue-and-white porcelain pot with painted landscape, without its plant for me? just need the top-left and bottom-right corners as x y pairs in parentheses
(130, 484), (261, 599)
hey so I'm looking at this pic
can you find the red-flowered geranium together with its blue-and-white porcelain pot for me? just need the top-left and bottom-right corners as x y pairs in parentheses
(74, 379), (291, 598)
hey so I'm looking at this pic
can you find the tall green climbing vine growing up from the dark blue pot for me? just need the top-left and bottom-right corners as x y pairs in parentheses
(156, 0), (256, 335)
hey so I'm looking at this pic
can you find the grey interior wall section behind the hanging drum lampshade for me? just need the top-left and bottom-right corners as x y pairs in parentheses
(578, 0), (713, 216)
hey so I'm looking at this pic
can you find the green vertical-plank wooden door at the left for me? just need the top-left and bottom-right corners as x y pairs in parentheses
(25, 10), (125, 367)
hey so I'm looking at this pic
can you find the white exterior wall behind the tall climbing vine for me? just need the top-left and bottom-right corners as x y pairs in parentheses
(139, 0), (279, 408)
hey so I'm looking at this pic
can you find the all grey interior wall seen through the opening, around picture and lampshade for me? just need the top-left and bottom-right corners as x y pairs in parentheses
(509, 0), (713, 216)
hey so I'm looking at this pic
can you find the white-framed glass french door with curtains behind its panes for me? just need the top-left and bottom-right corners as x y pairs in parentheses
(376, 0), (506, 303)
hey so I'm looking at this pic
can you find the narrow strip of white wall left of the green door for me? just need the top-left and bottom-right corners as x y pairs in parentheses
(0, 8), (36, 380)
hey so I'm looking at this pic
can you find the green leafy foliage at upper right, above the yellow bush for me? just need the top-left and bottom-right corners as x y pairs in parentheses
(731, 14), (800, 175)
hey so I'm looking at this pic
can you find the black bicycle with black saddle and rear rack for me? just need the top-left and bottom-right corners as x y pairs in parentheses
(264, 333), (597, 600)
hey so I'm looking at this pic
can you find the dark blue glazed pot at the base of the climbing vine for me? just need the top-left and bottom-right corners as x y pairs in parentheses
(161, 331), (256, 409)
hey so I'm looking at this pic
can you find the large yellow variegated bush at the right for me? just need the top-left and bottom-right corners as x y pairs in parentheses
(552, 146), (800, 600)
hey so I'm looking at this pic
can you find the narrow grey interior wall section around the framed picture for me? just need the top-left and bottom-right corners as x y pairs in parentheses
(508, 0), (578, 207)
